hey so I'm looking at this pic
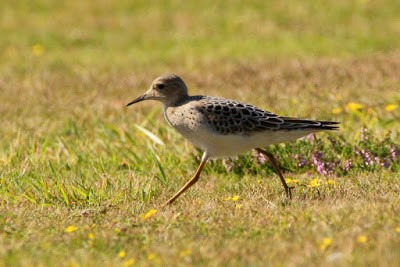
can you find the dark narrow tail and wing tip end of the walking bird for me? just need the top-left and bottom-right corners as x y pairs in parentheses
(280, 117), (340, 131)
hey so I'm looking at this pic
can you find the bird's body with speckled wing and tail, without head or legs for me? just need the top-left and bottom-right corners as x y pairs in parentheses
(164, 93), (337, 158)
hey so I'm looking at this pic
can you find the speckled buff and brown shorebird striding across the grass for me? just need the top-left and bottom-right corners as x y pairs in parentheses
(127, 74), (340, 207)
